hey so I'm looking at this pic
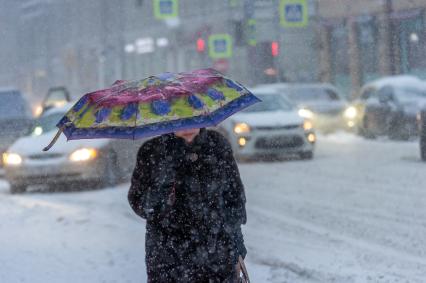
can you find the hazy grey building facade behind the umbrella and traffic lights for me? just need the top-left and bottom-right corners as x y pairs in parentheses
(4, 0), (318, 100)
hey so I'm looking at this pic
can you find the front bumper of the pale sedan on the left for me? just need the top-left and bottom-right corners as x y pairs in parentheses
(4, 160), (103, 185)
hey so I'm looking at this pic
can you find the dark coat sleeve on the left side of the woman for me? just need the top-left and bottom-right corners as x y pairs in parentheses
(128, 140), (175, 221)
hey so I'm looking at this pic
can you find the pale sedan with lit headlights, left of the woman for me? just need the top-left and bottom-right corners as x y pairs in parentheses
(3, 104), (141, 193)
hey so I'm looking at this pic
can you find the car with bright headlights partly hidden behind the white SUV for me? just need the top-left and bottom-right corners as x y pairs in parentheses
(258, 83), (358, 133)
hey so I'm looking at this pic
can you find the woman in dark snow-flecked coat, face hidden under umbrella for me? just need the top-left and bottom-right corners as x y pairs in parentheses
(129, 129), (246, 283)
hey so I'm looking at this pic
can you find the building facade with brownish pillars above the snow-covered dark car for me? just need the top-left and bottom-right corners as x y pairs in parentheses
(318, 0), (426, 94)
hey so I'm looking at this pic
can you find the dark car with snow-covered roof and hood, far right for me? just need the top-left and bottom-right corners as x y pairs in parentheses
(355, 76), (426, 140)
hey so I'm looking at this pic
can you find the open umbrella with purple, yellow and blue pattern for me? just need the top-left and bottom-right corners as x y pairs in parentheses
(44, 69), (260, 151)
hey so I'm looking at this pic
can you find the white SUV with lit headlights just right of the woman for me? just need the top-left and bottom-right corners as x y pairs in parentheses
(219, 89), (316, 160)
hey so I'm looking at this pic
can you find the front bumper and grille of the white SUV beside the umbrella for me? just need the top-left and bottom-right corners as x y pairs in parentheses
(230, 128), (315, 158)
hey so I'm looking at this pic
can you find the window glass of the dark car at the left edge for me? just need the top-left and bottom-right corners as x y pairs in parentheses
(0, 91), (27, 119)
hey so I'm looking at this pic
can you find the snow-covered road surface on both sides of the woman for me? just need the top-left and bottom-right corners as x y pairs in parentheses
(0, 134), (426, 283)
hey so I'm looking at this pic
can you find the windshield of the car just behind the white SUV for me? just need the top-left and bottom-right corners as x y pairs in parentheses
(284, 87), (339, 102)
